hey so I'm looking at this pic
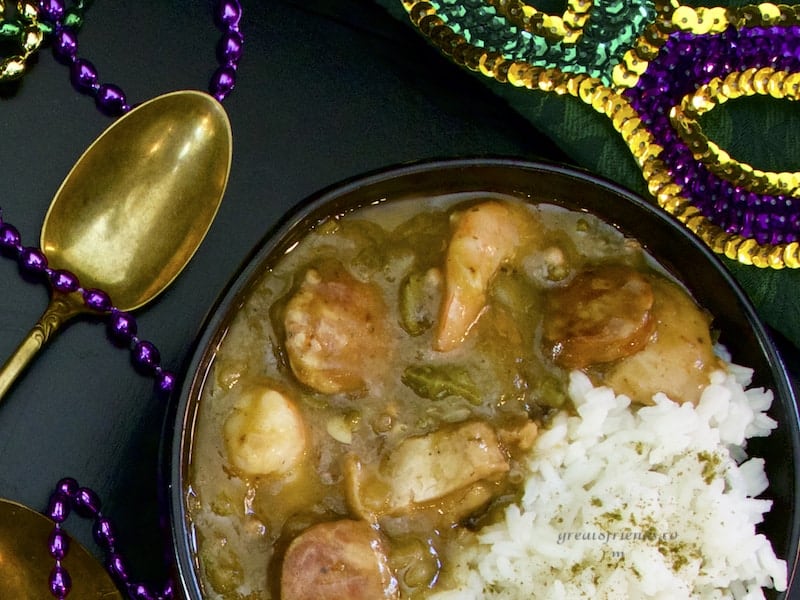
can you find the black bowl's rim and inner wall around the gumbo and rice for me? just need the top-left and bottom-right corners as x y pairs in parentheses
(167, 159), (800, 599)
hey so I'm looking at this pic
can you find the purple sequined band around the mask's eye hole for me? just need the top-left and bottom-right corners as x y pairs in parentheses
(623, 27), (800, 244)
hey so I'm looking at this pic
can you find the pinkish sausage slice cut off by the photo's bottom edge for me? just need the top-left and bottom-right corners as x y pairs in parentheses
(281, 520), (400, 600)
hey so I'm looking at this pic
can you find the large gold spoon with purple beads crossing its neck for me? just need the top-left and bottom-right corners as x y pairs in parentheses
(0, 91), (232, 399)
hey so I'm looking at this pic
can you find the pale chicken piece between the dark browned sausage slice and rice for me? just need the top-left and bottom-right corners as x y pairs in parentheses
(603, 279), (722, 404)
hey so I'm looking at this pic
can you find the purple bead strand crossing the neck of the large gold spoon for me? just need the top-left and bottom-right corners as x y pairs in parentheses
(0, 209), (175, 395)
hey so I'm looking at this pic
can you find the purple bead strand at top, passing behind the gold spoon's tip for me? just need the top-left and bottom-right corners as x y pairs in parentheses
(39, 0), (244, 116)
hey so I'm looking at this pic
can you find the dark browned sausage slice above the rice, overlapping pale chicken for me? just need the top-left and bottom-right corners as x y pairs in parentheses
(542, 265), (655, 369)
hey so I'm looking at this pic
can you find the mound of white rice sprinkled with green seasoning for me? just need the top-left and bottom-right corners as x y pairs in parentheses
(432, 358), (787, 600)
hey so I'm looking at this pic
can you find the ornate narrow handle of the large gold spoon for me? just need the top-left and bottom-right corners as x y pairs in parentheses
(0, 290), (86, 400)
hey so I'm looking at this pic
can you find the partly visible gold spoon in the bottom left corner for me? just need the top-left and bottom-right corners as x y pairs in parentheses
(0, 499), (122, 600)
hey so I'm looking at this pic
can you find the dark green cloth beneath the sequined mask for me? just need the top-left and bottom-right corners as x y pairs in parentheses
(379, 0), (800, 347)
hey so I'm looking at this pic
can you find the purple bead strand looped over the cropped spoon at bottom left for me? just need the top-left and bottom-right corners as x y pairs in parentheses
(47, 477), (175, 600)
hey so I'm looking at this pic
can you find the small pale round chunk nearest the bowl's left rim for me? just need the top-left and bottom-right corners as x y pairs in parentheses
(223, 385), (306, 475)
